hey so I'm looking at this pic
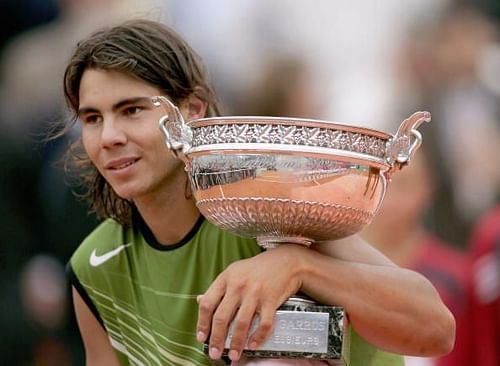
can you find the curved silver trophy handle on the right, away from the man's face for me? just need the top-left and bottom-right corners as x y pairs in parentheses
(386, 111), (431, 177)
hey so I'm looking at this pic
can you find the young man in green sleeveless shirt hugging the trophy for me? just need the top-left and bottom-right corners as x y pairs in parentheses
(63, 20), (454, 366)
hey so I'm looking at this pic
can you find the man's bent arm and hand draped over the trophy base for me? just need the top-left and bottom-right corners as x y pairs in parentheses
(198, 236), (455, 359)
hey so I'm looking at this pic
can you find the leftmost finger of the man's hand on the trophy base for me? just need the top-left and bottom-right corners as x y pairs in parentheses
(196, 278), (225, 343)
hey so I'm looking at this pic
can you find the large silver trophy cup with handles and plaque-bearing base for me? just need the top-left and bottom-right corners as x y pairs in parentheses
(152, 96), (430, 363)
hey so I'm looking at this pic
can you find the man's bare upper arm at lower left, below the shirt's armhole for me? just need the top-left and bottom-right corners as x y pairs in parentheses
(72, 288), (120, 366)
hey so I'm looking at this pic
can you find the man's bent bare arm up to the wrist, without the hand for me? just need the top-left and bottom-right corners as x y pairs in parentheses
(302, 236), (455, 356)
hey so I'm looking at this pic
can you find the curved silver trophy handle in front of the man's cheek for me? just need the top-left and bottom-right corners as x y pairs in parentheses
(151, 96), (193, 170)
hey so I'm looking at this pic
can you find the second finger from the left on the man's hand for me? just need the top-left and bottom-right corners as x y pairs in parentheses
(209, 294), (240, 359)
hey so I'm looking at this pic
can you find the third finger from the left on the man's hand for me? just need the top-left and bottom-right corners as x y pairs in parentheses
(229, 298), (257, 361)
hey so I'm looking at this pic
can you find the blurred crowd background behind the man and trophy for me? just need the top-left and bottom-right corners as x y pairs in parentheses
(0, 0), (500, 366)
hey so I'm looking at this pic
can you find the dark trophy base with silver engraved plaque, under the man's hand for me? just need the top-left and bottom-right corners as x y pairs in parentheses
(204, 297), (345, 366)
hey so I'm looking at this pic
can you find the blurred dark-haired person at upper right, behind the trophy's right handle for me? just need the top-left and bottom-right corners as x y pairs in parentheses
(396, 2), (500, 248)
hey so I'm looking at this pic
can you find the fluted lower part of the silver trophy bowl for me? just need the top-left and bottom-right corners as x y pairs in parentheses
(197, 197), (374, 247)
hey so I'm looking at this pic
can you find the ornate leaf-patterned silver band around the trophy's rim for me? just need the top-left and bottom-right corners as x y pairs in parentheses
(184, 116), (393, 169)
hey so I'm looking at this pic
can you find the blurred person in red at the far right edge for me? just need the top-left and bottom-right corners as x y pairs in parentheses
(469, 204), (500, 366)
